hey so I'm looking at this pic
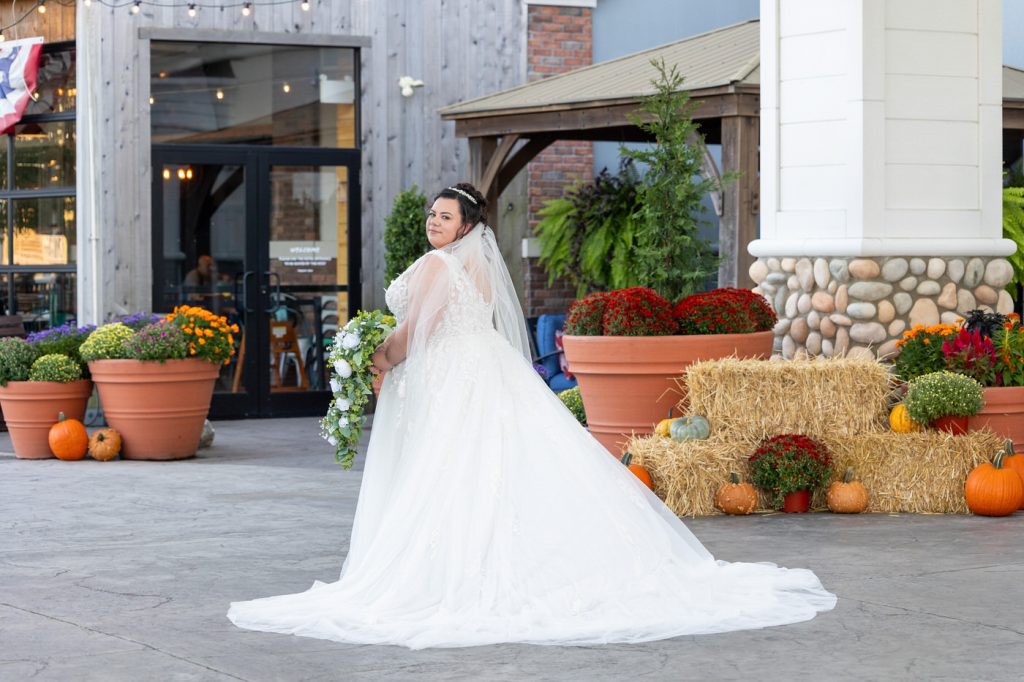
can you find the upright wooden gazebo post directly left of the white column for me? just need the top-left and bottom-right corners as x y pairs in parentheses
(718, 116), (761, 289)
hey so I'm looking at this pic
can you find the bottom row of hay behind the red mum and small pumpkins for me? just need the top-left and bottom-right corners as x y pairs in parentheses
(628, 430), (1002, 516)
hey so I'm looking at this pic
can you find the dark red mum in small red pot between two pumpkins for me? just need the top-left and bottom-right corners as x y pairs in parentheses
(749, 433), (831, 512)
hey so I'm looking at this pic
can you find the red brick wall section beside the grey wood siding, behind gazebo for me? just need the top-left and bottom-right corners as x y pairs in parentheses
(523, 4), (594, 315)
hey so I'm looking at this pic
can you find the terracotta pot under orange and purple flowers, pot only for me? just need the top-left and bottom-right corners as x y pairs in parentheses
(89, 357), (220, 460)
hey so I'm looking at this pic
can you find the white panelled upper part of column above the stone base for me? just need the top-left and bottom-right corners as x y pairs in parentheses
(750, 0), (1015, 257)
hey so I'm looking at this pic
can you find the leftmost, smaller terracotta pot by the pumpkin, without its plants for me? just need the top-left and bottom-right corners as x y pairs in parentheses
(0, 379), (92, 460)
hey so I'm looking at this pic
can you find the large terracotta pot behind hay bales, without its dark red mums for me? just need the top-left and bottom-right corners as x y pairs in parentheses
(562, 331), (775, 457)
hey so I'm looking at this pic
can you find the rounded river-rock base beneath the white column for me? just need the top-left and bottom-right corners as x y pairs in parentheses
(750, 256), (1014, 359)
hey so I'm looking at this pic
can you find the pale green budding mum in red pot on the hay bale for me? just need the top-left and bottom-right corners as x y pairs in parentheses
(903, 370), (983, 434)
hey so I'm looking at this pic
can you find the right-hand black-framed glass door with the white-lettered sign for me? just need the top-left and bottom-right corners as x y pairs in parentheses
(261, 150), (360, 415)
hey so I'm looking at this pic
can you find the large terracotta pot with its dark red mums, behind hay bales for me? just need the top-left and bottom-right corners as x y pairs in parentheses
(562, 287), (776, 455)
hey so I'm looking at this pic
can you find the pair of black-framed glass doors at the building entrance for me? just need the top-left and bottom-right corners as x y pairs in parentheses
(153, 145), (360, 419)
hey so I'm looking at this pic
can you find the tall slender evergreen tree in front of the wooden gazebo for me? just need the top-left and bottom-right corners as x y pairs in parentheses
(620, 60), (731, 301)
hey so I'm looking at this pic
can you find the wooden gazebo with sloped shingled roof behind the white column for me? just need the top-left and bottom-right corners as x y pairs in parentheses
(440, 20), (1024, 287)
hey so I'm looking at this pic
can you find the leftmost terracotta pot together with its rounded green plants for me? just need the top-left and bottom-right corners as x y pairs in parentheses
(0, 325), (92, 459)
